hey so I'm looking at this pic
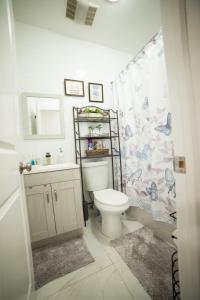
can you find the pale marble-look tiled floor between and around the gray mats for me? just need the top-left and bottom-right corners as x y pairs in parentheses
(37, 219), (150, 300)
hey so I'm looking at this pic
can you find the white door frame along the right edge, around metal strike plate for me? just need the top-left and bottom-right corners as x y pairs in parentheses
(160, 0), (200, 300)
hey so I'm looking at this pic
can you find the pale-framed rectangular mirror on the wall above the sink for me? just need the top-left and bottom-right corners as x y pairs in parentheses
(22, 93), (64, 140)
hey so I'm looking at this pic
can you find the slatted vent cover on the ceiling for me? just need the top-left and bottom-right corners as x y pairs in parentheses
(66, 0), (99, 26)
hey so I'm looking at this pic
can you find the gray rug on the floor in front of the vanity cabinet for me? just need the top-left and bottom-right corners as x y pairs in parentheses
(33, 238), (94, 289)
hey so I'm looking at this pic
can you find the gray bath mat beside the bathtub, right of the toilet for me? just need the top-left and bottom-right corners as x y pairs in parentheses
(112, 227), (174, 300)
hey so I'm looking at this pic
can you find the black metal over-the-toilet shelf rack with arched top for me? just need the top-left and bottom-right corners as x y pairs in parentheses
(73, 106), (123, 225)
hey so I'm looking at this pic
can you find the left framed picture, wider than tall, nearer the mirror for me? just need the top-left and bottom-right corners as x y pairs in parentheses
(64, 79), (85, 97)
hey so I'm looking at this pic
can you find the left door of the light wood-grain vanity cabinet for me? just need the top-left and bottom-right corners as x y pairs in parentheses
(26, 184), (56, 242)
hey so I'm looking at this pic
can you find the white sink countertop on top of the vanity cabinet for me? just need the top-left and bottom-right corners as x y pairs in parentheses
(23, 163), (79, 175)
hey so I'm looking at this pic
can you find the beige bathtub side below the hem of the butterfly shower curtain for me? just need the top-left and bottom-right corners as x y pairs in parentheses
(126, 206), (176, 245)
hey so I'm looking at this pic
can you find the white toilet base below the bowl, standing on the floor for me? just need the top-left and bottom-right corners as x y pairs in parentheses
(101, 212), (122, 239)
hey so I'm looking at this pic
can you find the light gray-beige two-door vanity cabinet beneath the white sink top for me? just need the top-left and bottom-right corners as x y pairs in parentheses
(24, 169), (83, 242)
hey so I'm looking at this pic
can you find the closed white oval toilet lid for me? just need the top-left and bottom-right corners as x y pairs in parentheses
(94, 189), (128, 206)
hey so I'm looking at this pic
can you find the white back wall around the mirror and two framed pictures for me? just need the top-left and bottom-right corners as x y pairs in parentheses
(16, 22), (131, 161)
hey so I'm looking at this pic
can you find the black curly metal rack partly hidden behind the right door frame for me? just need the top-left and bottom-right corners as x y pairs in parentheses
(170, 211), (181, 300)
